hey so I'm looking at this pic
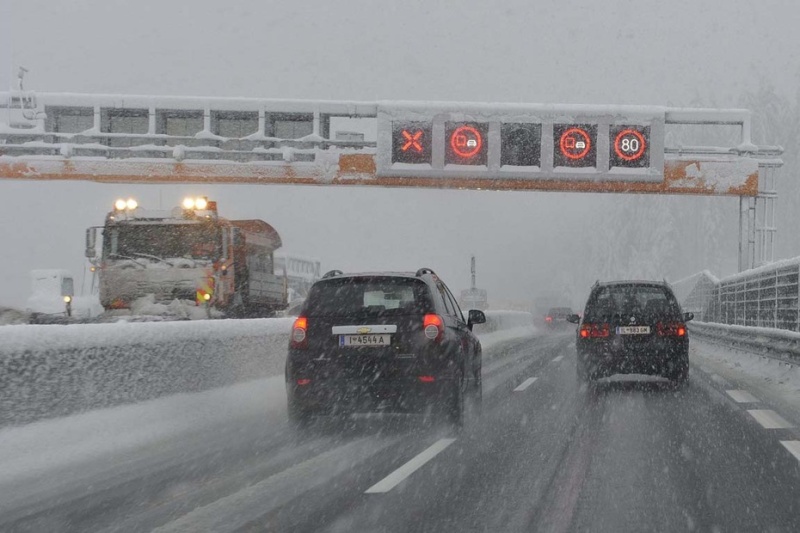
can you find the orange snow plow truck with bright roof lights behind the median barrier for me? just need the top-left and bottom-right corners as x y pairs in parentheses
(86, 197), (286, 317)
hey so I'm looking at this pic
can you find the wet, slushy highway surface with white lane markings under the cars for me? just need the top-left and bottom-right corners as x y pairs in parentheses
(0, 329), (800, 533)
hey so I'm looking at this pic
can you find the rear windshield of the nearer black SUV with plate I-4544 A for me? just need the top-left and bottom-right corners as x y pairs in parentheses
(305, 276), (433, 317)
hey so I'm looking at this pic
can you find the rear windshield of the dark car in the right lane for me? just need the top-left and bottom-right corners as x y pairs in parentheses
(586, 285), (680, 320)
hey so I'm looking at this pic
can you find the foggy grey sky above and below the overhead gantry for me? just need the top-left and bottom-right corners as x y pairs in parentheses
(0, 0), (800, 306)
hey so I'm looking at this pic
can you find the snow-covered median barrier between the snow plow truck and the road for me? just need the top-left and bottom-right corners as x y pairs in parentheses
(0, 311), (532, 427)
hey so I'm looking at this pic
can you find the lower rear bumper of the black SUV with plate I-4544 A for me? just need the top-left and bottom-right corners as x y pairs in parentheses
(286, 378), (454, 414)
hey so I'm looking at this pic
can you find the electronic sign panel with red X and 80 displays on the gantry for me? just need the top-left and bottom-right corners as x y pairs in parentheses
(376, 103), (665, 183)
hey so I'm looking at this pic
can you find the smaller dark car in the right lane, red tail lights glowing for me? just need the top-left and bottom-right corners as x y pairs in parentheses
(569, 281), (694, 383)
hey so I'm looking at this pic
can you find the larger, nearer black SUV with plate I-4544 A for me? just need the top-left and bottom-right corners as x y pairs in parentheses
(286, 268), (486, 425)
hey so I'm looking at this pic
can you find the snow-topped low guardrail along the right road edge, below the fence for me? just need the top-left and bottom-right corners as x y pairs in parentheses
(689, 321), (800, 364)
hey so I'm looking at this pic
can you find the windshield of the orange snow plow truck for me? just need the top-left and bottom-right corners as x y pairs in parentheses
(103, 224), (222, 260)
